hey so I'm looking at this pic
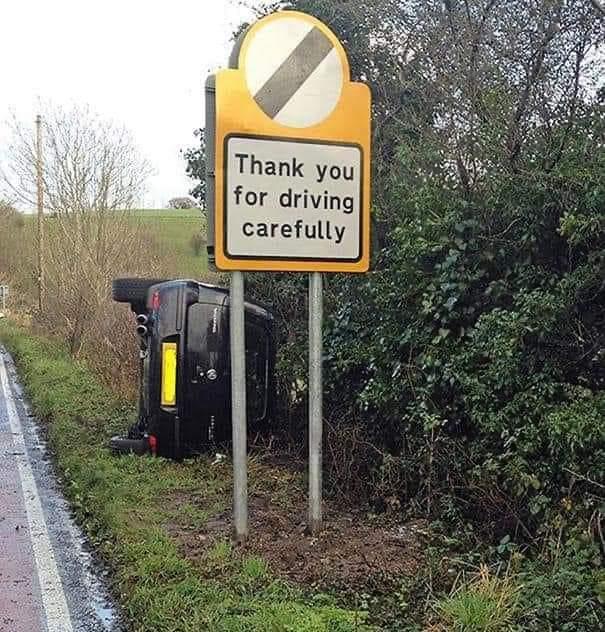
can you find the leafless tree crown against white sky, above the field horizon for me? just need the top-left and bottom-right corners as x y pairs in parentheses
(0, 107), (151, 214)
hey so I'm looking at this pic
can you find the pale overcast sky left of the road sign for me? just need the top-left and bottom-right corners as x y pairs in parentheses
(0, 0), (258, 207)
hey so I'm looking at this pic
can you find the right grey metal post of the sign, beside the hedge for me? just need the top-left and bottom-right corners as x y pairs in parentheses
(309, 272), (323, 534)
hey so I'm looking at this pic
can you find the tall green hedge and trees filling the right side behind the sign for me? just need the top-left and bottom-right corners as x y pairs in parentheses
(184, 8), (605, 631)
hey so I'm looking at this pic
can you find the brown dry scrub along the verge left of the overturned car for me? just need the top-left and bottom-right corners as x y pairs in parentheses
(0, 212), (169, 399)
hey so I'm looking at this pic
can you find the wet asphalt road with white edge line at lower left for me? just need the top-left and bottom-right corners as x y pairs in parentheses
(0, 347), (122, 632)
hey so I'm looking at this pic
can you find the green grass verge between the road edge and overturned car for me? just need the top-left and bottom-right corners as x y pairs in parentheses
(0, 321), (371, 632)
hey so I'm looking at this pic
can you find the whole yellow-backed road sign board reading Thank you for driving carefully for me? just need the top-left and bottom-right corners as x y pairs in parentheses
(215, 11), (371, 272)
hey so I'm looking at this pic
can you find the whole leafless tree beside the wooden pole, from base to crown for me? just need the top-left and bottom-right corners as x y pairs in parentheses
(0, 108), (154, 355)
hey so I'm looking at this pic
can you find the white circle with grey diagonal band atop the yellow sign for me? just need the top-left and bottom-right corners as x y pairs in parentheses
(243, 15), (345, 128)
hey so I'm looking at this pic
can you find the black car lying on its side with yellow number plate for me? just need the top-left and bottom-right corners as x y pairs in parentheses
(111, 278), (275, 460)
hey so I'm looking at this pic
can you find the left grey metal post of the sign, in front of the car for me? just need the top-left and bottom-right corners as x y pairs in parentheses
(229, 272), (248, 543)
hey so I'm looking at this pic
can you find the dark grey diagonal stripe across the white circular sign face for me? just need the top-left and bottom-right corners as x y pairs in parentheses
(254, 27), (334, 118)
